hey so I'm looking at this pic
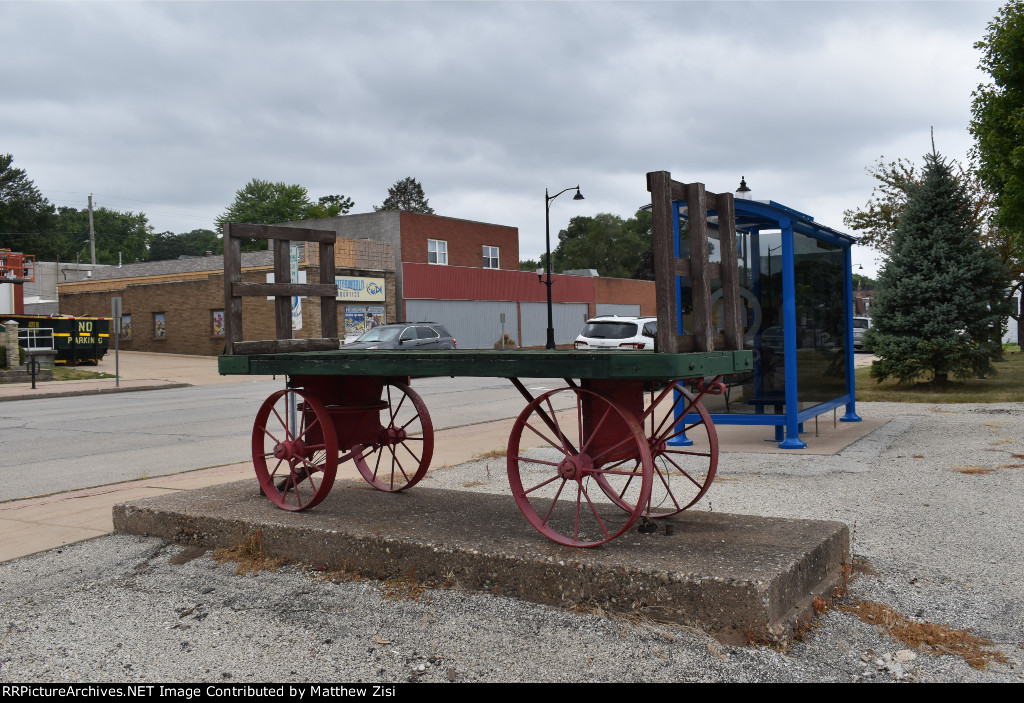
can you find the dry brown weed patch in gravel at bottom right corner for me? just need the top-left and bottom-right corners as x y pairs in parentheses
(839, 601), (1007, 669)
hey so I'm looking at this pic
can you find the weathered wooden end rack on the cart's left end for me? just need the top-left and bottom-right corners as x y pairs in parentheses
(224, 222), (341, 354)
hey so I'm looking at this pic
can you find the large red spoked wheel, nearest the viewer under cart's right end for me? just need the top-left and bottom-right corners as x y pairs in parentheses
(508, 388), (652, 546)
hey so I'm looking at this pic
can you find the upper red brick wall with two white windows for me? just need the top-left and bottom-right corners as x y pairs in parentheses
(400, 213), (519, 270)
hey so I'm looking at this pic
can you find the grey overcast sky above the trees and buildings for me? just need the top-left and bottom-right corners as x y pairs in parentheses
(0, 0), (1001, 274)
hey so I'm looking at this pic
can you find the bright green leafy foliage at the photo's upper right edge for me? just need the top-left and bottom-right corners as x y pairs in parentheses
(971, 0), (1024, 237)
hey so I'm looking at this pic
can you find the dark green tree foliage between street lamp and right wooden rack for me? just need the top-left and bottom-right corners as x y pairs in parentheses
(551, 210), (651, 278)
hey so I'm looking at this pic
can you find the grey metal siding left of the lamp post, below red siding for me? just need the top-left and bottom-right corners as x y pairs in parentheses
(406, 300), (520, 349)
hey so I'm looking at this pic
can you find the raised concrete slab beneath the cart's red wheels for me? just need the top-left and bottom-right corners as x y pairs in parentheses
(114, 480), (849, 644)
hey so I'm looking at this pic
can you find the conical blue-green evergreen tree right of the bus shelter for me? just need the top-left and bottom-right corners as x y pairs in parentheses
(864, 152), (1008, 384)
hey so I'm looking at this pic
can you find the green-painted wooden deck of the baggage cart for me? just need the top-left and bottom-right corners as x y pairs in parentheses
(218, 349), (754, 381)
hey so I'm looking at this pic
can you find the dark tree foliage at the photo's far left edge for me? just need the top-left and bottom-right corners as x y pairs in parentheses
(0, 153), (56, 259)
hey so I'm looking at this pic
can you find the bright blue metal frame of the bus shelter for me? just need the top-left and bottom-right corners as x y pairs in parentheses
(673, 200), (860, 449)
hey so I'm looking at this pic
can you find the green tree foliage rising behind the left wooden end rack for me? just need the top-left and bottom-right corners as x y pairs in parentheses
(217, 178), (354, 251)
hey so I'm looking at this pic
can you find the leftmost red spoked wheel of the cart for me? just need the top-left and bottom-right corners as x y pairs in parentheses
(252, 389), (338, 511)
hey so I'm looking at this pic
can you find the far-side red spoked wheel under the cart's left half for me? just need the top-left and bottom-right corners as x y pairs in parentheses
(352, 383), (434, 492)
